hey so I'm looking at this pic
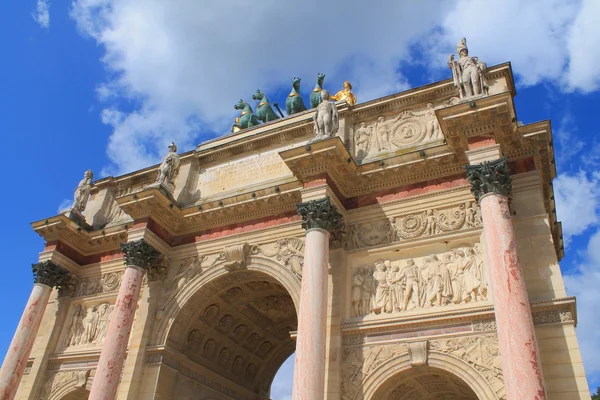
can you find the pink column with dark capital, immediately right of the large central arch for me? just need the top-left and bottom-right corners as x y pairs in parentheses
(292, 197), (342, 400)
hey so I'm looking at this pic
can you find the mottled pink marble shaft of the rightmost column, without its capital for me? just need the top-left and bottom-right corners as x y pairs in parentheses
(480, 193), (546, 400)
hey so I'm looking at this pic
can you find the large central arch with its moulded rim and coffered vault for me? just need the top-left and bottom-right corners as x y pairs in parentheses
(154, 254), (301, 399)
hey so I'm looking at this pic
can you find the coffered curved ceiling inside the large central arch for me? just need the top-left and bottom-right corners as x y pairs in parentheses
(169, 272), (297, 391)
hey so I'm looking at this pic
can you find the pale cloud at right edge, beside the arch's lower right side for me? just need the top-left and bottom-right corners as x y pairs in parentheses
(564, 231), (600, 383)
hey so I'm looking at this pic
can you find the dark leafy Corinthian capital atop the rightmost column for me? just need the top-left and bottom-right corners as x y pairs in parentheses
(466, 157), (512, 200)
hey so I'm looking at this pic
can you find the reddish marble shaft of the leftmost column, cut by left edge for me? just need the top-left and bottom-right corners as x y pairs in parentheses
(0, 283), (52, 400)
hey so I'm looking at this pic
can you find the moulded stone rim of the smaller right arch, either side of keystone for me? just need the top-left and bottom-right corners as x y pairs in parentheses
(354, 351), (499, 400)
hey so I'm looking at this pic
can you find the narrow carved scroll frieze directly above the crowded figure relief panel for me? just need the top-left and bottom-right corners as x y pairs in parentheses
(344, 201), (482, 250)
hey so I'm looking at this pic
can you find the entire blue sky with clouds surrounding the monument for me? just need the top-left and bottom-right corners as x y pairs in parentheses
(0, 0), (600, 399)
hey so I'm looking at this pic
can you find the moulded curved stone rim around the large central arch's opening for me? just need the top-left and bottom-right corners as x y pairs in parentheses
(153, 255), (301, 344)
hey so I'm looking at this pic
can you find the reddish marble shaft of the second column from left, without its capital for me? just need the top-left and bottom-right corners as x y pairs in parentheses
(89, 265), (144, 400)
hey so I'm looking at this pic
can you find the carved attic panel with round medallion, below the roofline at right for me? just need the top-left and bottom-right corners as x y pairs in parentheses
(354, 103), (447, 160)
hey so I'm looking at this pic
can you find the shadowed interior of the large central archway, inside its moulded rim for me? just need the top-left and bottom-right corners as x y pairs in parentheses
(157, 264), (299, 400)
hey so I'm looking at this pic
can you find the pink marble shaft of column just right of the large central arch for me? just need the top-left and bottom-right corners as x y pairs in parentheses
(293, 229), (329, 400)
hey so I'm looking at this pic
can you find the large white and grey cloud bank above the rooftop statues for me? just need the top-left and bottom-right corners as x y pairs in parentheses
(71, 0), (600, 174)
